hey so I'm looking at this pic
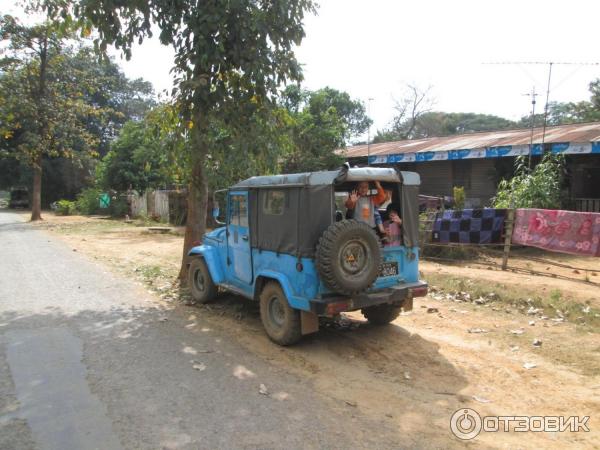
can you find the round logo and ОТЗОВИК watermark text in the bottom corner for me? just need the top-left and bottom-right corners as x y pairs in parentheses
(450, 408), (590, 440)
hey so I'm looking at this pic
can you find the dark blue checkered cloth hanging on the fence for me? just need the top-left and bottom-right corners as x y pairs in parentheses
(432, 208), (506, 244)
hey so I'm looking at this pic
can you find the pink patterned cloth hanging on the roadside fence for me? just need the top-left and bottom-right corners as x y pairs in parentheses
(512, 209), (600, 256)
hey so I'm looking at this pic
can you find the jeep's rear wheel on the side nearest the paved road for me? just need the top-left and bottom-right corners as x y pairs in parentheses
(260, 281), (302, 345)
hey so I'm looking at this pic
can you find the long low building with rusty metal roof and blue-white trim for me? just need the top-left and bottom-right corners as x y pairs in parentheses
(339, 122), (600, 211)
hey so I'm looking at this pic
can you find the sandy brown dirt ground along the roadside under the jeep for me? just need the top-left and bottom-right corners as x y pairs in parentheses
(24, 213), (600, 448)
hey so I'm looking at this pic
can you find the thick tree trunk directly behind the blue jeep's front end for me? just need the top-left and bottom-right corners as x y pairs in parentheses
(179, 120), (208, 281)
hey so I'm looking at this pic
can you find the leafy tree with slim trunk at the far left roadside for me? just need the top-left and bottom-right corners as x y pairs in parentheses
(0, 15), (98, 220)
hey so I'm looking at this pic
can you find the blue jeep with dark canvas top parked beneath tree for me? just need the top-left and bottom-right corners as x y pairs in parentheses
(188, 165), (427, 345)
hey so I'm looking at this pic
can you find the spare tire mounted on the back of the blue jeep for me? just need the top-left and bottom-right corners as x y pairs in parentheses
(316, 220), (381, 295)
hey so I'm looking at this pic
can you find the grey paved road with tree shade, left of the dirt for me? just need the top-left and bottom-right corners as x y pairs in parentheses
(0, 210), (393, 450)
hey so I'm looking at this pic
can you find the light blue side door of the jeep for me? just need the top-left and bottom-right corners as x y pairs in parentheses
(227, 191), (253, 284)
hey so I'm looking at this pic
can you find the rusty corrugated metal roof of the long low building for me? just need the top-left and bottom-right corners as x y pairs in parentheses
(339, 122), (600, 158)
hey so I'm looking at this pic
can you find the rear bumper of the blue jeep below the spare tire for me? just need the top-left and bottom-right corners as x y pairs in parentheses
(310, 281), (427, 316)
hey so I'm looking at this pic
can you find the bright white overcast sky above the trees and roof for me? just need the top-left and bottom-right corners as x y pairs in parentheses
(0, 0), (600, 139)
